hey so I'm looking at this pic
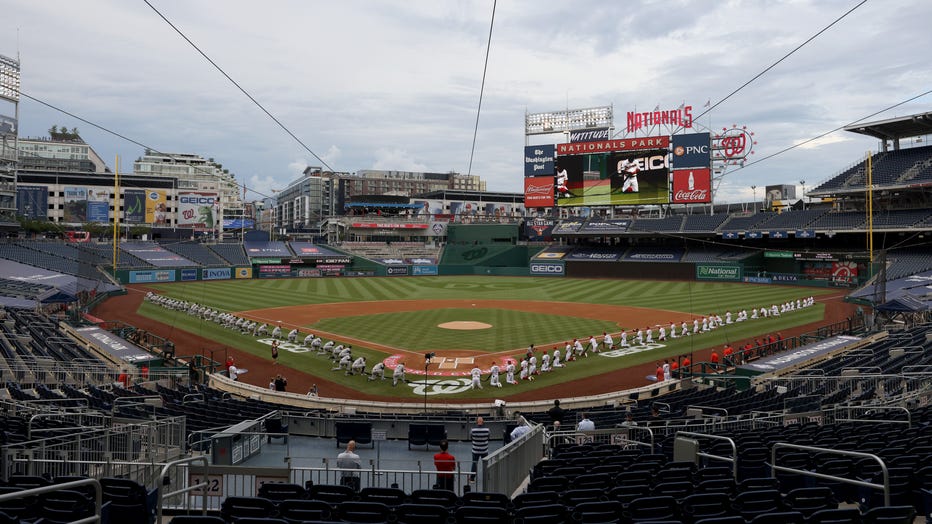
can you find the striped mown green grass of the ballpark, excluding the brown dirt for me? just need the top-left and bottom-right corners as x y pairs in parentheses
(139, 277), (837, 398)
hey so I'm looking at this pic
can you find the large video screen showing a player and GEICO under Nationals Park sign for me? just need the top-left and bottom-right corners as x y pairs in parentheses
(556, 149), (670, 206)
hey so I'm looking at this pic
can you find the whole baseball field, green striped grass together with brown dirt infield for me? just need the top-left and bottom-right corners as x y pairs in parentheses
(122, 276), (840, 400)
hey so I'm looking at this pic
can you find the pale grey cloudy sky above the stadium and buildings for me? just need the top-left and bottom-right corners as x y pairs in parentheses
(0, 0), (932, 202)
